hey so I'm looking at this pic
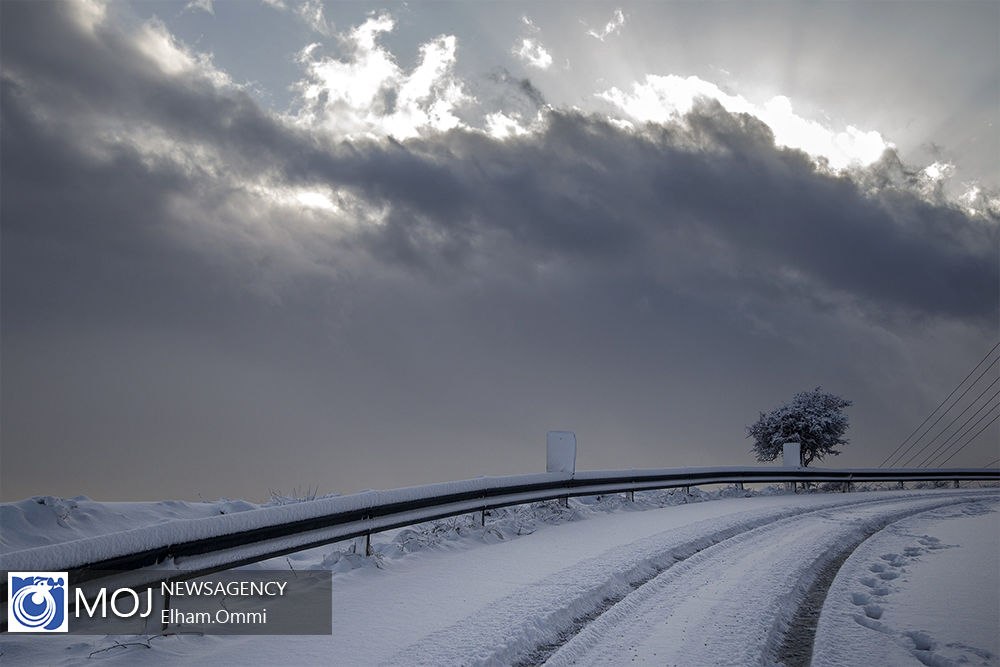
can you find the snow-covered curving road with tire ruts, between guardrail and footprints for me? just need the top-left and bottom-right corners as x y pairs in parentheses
(0, 490), (1000, 665)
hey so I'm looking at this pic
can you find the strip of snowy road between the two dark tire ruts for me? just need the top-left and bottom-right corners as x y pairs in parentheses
(532, 494), (992, 665)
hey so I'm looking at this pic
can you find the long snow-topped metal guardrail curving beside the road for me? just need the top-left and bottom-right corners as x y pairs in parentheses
(0, 467), (1000, 627)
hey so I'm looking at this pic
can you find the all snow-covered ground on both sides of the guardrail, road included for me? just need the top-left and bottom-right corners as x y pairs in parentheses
(0, 488), (1000, 665)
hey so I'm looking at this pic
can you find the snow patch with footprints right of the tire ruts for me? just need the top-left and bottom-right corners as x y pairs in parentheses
(813, 503), (1000, 665)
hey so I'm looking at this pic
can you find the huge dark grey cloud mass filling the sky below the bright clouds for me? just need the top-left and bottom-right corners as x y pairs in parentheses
(0, 2), (1000, 498)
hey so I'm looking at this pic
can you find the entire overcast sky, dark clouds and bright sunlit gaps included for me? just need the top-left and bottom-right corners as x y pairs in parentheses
(0, 0), (1000, 500)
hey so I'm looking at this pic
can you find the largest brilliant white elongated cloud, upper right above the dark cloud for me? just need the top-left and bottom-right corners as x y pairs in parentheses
(598, 74), (892, 169)
